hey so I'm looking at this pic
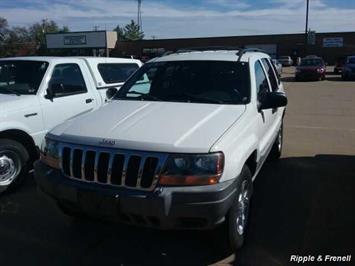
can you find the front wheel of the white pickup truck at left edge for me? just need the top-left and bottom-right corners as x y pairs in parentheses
(0, 139), (29, 193)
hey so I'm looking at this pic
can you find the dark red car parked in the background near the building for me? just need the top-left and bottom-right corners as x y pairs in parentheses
(295, 56), (326, 81)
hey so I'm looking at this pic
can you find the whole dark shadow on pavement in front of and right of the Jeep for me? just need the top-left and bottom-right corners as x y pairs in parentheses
(0, 155), (355, 266)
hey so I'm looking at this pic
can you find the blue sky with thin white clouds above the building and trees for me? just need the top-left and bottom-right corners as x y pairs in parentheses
(0, 0), (355, 39)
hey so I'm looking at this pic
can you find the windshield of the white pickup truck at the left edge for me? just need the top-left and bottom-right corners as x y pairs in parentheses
(0, 60), (48, 95)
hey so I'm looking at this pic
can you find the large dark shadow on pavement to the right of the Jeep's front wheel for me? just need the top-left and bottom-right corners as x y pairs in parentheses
(236, 155), (355, 266)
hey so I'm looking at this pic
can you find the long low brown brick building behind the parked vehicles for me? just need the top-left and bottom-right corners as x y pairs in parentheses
(111, 32), (355, 64)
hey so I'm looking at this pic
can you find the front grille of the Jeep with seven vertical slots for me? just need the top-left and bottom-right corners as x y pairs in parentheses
(60, 145), (168, 191)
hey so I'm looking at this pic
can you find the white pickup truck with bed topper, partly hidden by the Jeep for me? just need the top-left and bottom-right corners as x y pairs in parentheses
(0, 57), (142, 192)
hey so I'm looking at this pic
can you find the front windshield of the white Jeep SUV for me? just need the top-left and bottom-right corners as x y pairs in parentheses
(115, 61), (250, 104)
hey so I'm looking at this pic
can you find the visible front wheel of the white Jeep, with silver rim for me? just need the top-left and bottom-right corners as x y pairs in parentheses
(226, 166), (253, 252)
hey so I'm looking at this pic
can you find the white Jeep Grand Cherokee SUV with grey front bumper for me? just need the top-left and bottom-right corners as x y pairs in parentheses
(35, 49), (287, 250)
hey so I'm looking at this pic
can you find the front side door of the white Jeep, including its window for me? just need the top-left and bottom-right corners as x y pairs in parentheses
(254, 60), (274, 163)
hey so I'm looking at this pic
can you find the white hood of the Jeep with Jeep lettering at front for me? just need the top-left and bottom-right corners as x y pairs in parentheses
(50, 101), (246, 153)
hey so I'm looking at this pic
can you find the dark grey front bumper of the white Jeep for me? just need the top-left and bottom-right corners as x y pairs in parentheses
(34, 161), (236, 229)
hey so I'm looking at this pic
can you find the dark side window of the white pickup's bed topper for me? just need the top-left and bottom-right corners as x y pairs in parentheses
(97, 63), (139, 84)
